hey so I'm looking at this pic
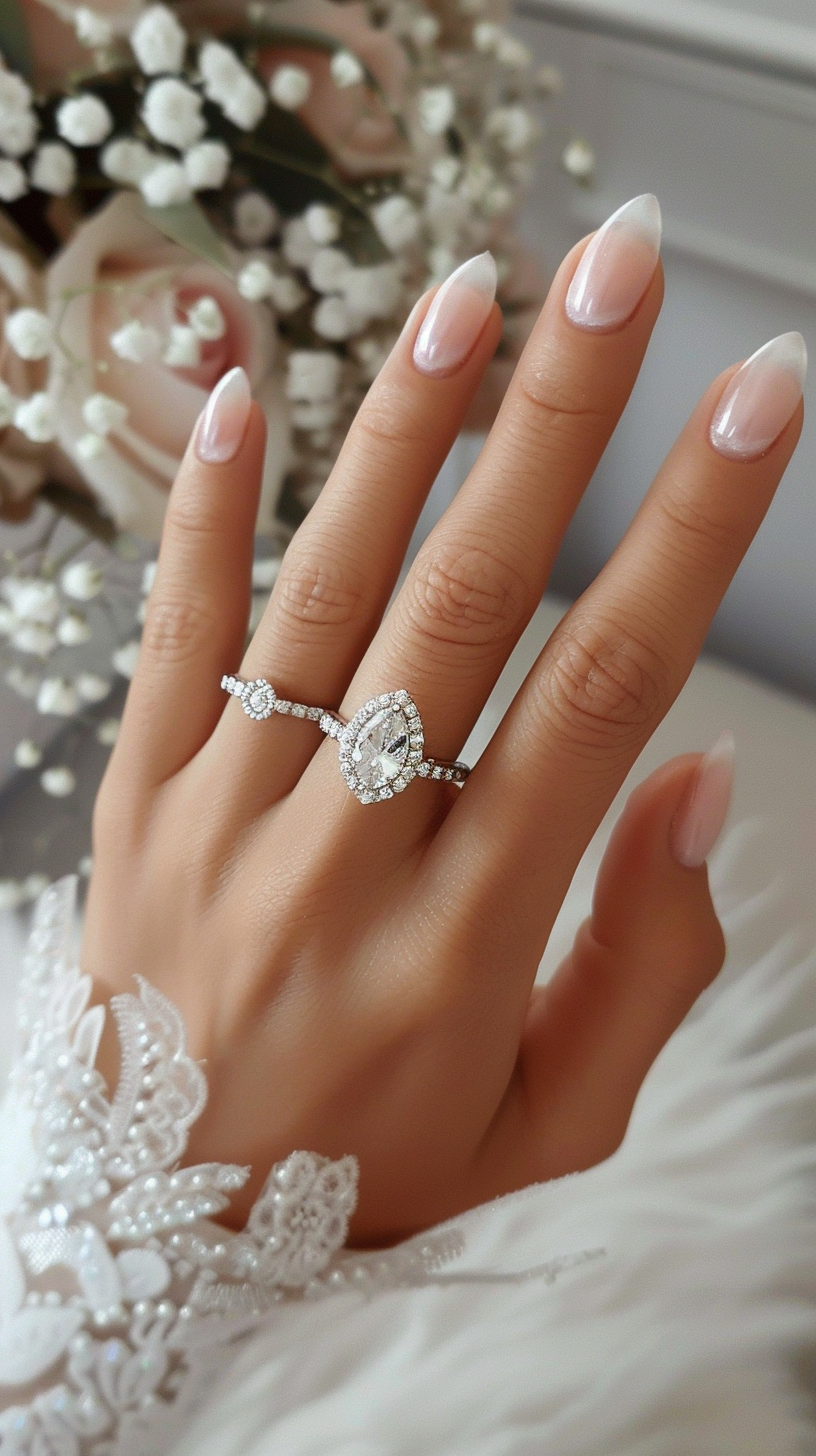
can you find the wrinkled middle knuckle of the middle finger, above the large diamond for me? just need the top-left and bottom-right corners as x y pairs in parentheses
(408, 543), (526, 648)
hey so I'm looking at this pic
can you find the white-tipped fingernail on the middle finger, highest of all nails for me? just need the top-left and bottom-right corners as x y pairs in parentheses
(565, 192), (662, 329)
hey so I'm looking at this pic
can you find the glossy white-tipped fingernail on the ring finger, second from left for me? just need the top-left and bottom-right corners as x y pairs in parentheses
(414, 253), (497, 376)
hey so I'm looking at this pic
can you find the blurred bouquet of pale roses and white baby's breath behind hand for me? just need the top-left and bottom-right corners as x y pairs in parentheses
(0, 0), (557, 898)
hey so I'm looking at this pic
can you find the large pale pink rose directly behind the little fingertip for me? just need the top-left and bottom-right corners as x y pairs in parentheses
(47, 192), (290, 537)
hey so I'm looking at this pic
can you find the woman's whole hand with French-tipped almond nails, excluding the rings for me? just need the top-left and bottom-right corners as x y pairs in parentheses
(83, 198), (804, 1243)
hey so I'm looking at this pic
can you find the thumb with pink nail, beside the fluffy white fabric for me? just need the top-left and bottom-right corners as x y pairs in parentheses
(522, 734), (733, 1176)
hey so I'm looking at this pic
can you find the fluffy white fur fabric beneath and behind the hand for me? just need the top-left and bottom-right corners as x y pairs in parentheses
(1, 603), (816, 1456)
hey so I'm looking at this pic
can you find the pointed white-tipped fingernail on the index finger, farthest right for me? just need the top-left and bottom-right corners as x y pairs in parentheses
(710, 333), (807, 460)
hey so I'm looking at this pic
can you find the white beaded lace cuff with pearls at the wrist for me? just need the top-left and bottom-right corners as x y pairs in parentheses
(0, 877), (599, 1456)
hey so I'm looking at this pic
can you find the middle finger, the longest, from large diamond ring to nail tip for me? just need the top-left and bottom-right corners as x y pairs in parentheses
(342, 195), (663, 786)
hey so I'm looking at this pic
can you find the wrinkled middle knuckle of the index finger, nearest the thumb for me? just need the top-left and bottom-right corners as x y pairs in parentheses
(539, 622), (667, 748)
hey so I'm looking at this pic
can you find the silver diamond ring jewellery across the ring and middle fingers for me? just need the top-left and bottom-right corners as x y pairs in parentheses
(221, 673), (471, 804)
